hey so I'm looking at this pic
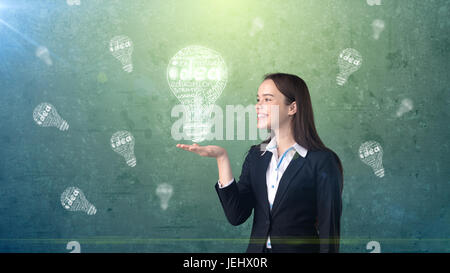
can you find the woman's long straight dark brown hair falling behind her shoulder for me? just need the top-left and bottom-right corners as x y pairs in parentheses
(259, 73), (344, 191)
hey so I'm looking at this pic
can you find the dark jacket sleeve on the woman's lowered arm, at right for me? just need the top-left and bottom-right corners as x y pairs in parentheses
(316, 150), (342, 253)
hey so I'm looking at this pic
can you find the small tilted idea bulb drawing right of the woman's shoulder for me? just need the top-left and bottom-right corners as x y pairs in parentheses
(359, 141), (384, 177)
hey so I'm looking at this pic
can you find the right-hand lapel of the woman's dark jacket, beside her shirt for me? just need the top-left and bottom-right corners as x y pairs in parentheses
(264, 153), (306, 215)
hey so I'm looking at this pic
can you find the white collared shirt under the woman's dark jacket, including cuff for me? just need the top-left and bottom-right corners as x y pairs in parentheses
(217, 137), (308, 248)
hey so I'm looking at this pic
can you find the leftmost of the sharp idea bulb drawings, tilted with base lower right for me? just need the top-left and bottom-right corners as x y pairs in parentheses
(33, 102), (69, 131)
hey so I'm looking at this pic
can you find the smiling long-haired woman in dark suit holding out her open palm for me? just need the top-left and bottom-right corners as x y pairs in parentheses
(177, 73), (343, 252)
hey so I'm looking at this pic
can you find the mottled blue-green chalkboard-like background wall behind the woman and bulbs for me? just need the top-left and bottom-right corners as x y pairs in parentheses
(0, 0), (450, 252)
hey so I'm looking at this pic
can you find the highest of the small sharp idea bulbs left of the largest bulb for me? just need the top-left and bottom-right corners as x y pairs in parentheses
(109, 35), (133, 73)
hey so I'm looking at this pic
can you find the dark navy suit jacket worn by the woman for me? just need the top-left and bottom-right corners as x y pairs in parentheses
(215, 145), (343, 253)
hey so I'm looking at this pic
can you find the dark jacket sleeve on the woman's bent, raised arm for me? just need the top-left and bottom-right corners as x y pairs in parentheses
(215, 149), (255, 226)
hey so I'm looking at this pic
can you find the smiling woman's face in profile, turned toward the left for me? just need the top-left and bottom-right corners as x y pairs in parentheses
(256, 79), (295, 130)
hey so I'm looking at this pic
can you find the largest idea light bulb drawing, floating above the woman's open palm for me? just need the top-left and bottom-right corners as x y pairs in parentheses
(167, 46), (228, 142)
